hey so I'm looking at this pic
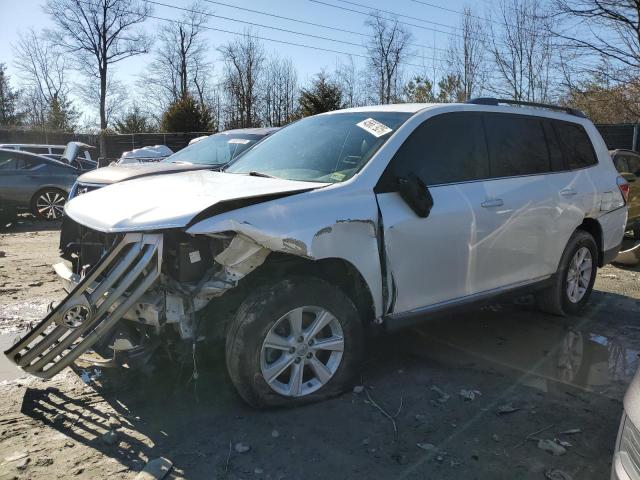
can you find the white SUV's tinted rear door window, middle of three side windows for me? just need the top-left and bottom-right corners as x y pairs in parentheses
(485, 114), (552, 178)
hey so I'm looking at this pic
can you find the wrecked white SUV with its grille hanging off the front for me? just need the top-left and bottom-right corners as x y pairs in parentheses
(7, 99), (628, 406)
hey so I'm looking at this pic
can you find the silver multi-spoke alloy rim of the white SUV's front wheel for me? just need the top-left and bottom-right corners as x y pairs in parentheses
(260, 306), (344, 397)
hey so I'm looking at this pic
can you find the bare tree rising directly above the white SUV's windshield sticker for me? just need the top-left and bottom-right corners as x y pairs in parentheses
(365, 12), (411, 104)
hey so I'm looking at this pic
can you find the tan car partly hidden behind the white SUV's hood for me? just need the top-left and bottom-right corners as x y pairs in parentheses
(69, 127), (278, 198)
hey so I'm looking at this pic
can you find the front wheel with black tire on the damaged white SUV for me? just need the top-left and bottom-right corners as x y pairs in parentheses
(225, 277), (364, 408)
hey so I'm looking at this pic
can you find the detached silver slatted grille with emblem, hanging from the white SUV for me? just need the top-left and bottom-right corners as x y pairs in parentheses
(5, 233), (162, 378)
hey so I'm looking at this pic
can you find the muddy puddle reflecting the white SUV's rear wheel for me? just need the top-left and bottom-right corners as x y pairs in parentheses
(411, 309), (639, 398)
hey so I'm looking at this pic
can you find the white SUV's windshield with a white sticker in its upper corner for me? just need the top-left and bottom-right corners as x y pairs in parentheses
(226, 112), (411, 183)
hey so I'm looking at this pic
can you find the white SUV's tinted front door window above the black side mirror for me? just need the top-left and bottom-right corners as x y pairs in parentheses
(390, 112), (489, 185)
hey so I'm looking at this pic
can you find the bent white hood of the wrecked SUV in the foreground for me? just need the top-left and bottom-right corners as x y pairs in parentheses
(65, 170), (327, 232)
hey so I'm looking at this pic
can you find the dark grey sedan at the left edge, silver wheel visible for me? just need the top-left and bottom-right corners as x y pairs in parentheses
(0, 149), (80, 220)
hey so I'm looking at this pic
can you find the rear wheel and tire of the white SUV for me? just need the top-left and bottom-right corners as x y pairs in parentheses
(536, 230), (598, 316)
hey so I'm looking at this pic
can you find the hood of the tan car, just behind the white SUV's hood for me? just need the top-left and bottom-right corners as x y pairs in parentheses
(78, 162), (209, 185)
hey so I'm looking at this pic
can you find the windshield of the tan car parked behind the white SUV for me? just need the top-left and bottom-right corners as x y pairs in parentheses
(162, 133), (262, 165)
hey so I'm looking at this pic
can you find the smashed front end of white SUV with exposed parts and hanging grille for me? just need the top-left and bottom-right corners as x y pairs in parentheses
(5, 230), (270, 378)
